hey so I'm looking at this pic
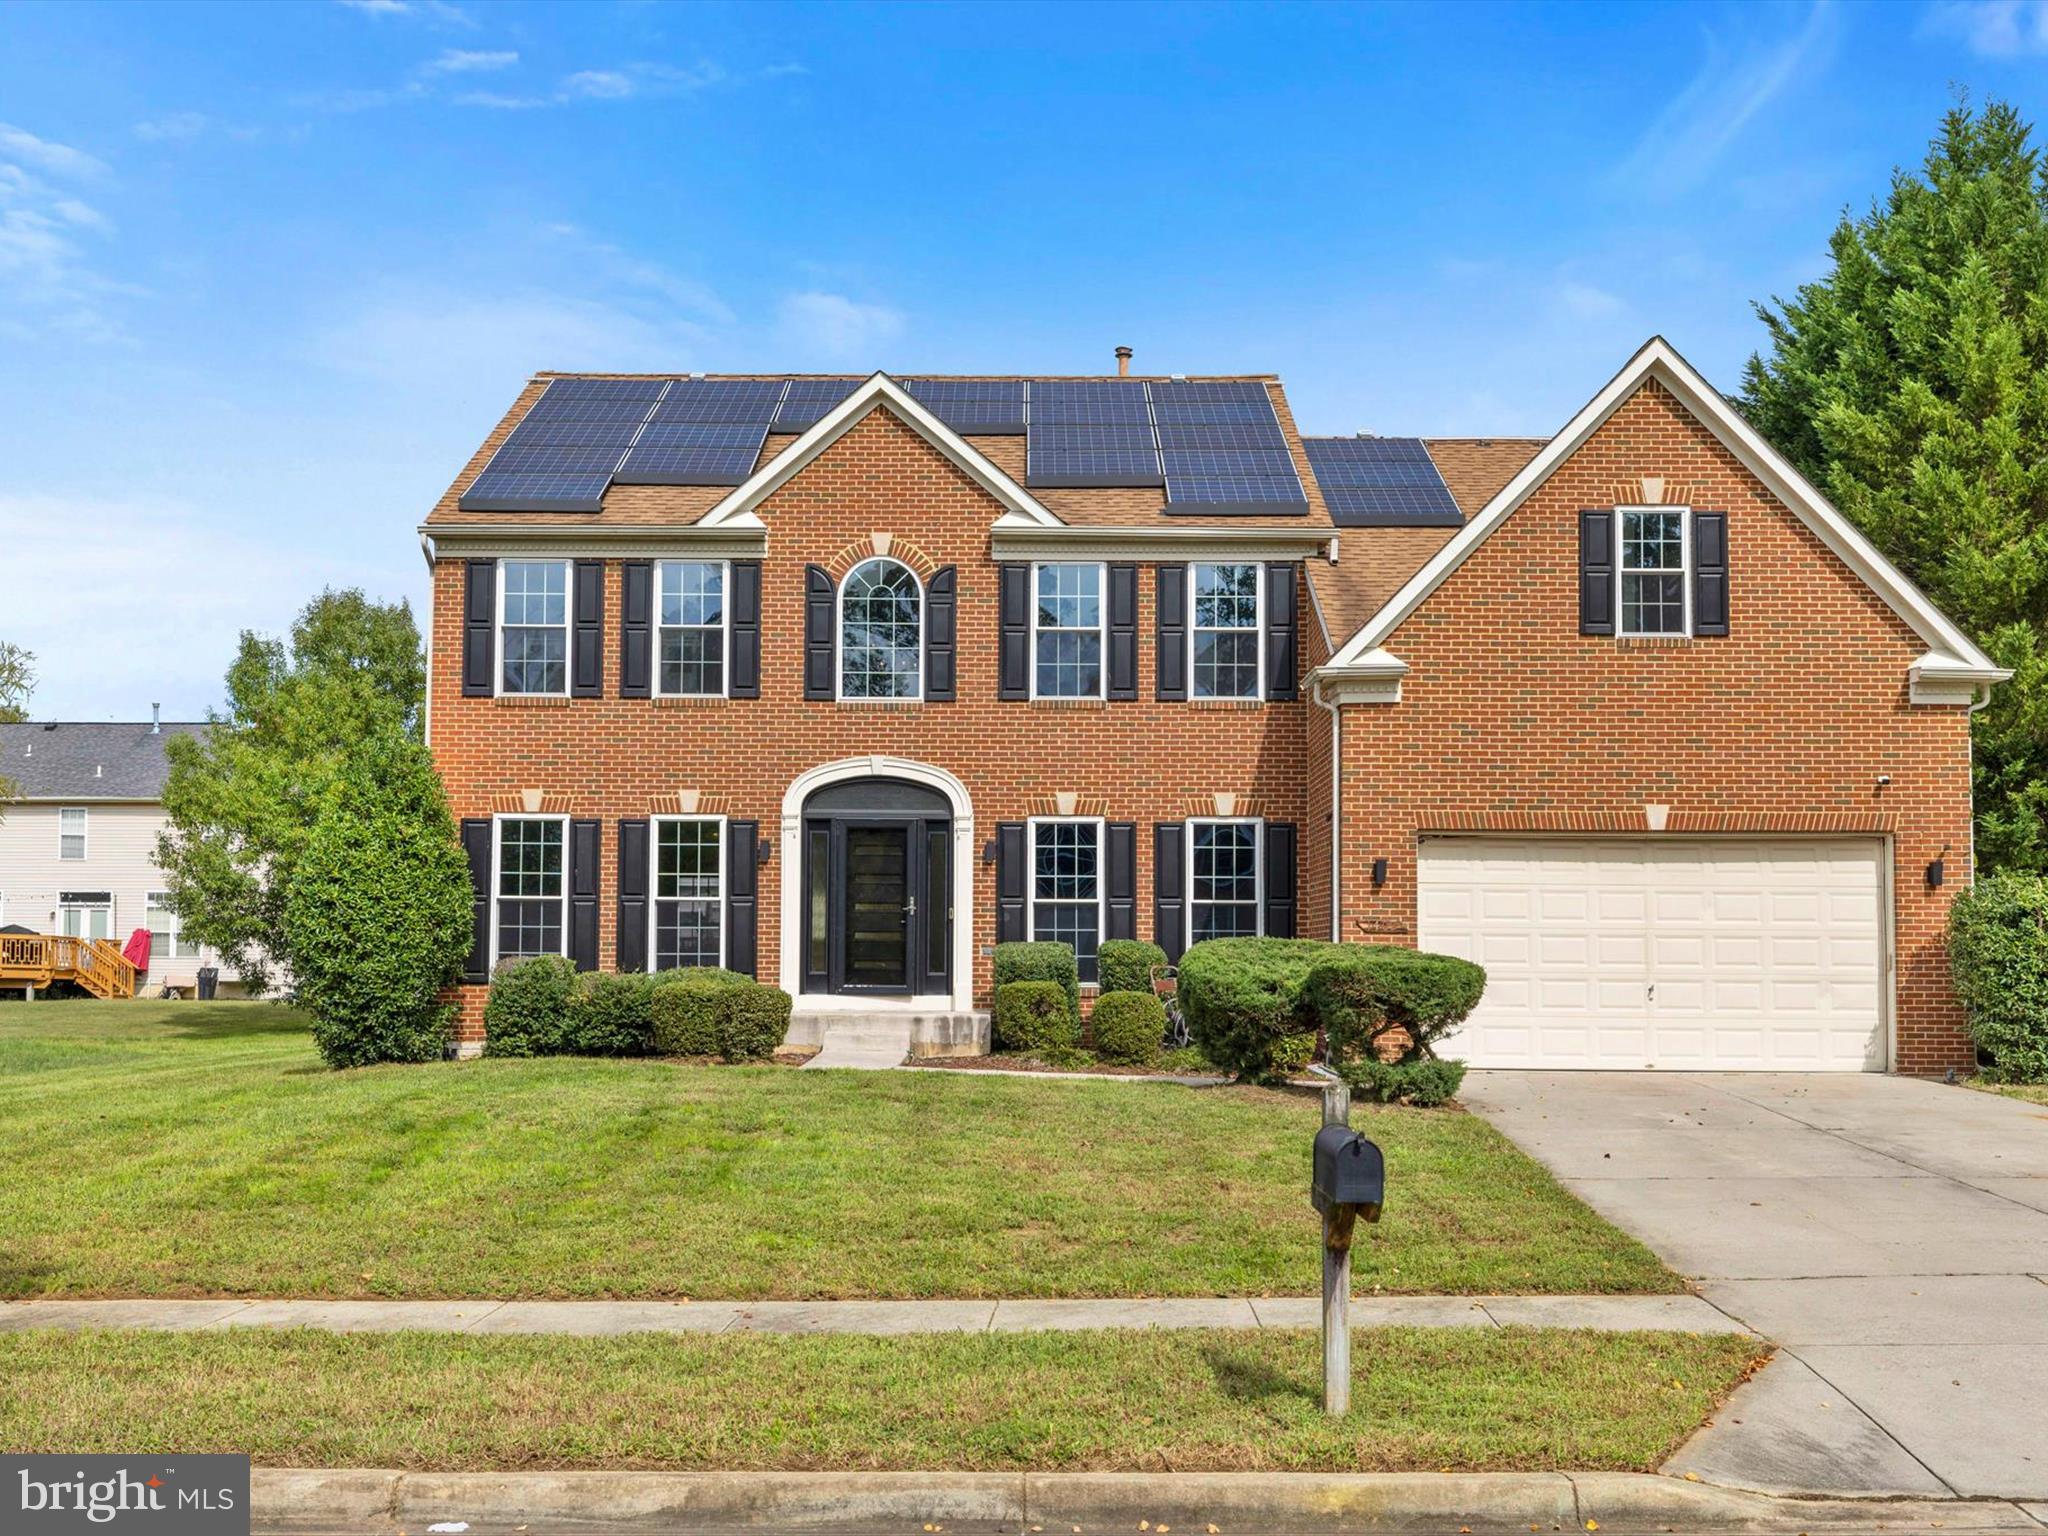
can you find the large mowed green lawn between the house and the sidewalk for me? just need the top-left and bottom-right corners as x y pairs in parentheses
(0, 1001), (1681, 1302)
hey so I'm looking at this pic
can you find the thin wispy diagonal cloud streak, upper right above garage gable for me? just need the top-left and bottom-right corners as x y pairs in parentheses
(1612, 0), (1835, 197)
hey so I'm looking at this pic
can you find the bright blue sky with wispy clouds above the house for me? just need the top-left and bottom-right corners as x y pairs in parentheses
(0, 0), (2048, 719)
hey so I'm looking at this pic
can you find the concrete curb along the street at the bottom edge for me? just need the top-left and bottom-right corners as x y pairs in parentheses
(250, 1466), (2042, 1536)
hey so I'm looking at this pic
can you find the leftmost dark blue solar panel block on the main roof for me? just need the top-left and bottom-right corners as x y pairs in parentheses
(461, 379), (668, 512)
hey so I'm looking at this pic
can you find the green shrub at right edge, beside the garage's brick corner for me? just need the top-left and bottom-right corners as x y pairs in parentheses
(1948, 874), (2048, 1083)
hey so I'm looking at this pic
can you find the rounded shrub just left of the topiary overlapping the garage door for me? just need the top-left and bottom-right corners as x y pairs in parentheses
(1180, 938), (1346, 1083)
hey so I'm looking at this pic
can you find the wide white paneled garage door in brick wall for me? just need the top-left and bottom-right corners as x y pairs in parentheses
(1417, 838), (1884, 1071)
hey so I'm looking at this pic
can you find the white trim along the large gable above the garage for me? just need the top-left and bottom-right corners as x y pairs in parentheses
(1321, 336), (2011, 702)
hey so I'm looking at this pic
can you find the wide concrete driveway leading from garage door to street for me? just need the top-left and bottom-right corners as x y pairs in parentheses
(1464, 1071), (2048, 1499)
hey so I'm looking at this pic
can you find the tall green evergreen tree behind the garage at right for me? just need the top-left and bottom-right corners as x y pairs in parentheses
(1741, 102), (2048, 870)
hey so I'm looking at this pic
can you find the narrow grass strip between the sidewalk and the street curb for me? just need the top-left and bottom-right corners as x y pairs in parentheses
(0, 1329), (1761, 1470)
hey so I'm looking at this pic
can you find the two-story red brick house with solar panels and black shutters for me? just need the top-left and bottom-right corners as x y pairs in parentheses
(422, 340), (2003, 1071)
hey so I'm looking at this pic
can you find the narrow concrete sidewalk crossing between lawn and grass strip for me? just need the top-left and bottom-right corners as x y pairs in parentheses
(0, 1296), (1745, 1335)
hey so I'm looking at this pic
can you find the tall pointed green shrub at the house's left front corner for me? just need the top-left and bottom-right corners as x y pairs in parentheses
(283, 739), (471, 1067)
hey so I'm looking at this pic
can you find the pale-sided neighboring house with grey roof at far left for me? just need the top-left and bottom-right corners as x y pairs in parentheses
(0, 721), (236, 995)
